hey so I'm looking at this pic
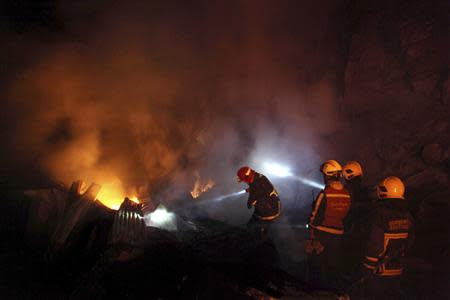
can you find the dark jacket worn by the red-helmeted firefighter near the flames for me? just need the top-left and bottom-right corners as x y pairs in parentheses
(247, 173), (281, 221)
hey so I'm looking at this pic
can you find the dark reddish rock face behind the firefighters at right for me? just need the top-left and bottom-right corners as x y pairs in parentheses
(341, 0), (450, 296)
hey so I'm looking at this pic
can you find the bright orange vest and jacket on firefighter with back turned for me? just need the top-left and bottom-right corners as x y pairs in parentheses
(308, 181), (351, 235)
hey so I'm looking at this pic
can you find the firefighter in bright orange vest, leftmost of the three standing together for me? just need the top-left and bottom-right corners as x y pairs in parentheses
(305, 160), (351, 291)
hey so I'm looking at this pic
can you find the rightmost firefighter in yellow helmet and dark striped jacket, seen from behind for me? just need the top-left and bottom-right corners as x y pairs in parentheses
(356, 176), (414, 299)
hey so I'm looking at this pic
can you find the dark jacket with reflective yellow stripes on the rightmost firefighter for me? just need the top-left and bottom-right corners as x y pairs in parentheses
(363, 199), (414, 276)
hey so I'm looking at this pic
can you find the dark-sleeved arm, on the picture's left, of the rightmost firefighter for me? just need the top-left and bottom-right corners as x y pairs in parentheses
(363, 215), (384, 273)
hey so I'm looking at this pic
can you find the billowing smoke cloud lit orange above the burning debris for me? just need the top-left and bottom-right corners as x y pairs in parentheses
(1, 1), (346, 209)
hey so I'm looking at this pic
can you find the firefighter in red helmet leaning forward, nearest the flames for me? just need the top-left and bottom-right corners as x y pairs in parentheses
(237, 167), (281, 237)
